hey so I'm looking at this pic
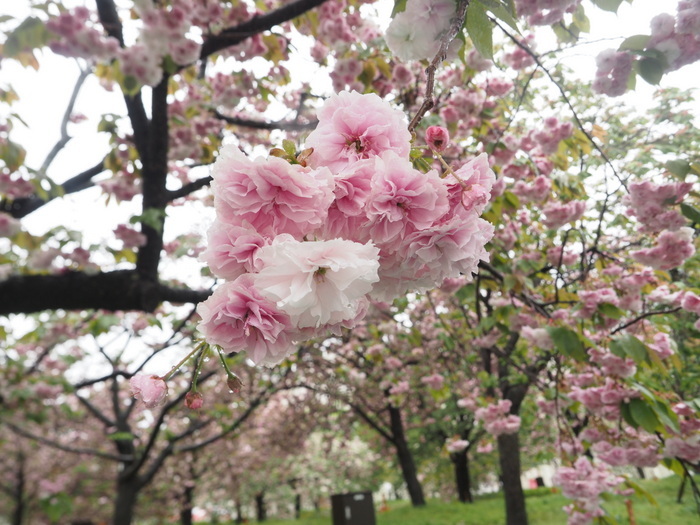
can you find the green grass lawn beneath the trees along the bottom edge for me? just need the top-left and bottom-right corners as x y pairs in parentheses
(237, 477), (700, 525)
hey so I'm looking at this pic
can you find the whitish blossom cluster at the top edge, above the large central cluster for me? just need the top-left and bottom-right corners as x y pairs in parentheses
(385, 0), (456, 62)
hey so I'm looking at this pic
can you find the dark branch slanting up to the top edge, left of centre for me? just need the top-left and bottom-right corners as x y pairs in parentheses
(199, 0), (326, 60)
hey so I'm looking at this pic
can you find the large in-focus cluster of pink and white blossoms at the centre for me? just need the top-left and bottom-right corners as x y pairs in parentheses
(198, 92), (495, 365)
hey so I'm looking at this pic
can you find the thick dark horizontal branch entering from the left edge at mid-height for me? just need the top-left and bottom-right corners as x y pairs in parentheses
(0, 270), (211, 315)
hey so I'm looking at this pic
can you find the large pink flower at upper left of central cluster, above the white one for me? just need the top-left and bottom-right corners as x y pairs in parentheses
(211, 145), (333, 238)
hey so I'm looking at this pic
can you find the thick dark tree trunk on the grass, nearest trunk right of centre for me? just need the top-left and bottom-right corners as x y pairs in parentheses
(498, 432), (527, 525)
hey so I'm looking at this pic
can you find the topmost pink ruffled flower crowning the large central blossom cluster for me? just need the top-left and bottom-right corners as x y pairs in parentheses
(306, 91), (411, 173)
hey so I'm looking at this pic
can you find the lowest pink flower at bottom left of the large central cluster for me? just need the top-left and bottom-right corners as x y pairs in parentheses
(197, 274), (295, 366)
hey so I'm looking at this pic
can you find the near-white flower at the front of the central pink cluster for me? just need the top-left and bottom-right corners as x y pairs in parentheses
(255, 236), (379, 328)
